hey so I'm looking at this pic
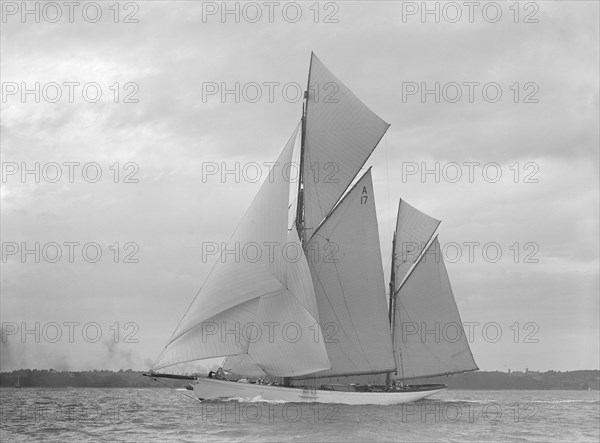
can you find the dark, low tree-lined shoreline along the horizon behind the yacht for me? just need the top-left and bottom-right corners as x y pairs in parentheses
(0, 369), (600, 391)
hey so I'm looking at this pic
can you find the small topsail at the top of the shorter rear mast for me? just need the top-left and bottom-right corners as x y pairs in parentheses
(394, 200), (440, 288)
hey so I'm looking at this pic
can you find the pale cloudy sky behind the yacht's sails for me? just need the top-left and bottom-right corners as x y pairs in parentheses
(0, 1), (600, 371)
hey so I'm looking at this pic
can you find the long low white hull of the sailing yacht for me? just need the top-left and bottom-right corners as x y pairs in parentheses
(194, 378), (444, 405)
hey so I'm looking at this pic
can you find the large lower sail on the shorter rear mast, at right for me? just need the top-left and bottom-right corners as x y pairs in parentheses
(394, 238), (477, 378)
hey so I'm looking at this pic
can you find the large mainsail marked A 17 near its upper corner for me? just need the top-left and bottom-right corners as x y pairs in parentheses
(307, 169), (395, 375)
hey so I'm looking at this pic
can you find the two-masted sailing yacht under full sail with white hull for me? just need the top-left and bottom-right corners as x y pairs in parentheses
(146, 53), (478, 405)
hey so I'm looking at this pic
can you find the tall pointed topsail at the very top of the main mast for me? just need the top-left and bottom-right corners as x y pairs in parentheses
(303, 54), (389, 239)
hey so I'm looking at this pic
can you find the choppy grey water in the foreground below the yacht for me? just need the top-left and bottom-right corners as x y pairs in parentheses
(0, 388), (600, 442)
